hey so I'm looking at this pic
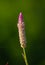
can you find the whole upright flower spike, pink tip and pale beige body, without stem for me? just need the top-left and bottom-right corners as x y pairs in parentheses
(17, 12), (26, 48)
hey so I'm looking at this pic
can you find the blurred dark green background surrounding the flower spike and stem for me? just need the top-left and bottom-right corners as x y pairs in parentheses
(0, 0), (45, 65)
